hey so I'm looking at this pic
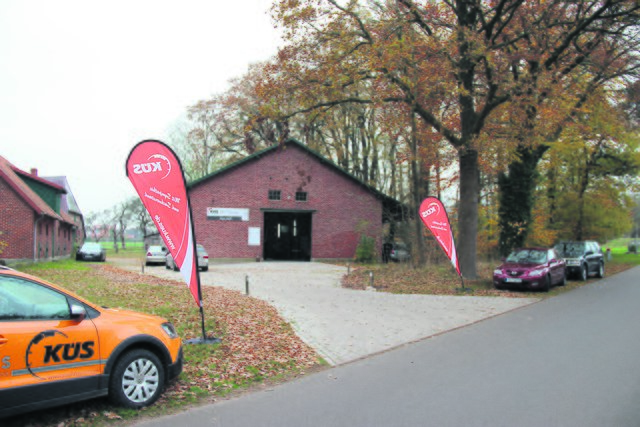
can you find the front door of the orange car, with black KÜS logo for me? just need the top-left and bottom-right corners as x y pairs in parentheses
(0, 275), (102, 413)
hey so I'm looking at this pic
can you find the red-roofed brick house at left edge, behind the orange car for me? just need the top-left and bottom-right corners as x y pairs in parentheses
(0, 156), (84, 263)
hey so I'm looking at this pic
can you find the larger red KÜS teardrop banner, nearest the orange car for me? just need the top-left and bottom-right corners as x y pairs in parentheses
(126, 140), (202, 307)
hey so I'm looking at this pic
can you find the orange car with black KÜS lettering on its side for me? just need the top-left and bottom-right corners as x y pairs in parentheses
(0, 266), (182, 418)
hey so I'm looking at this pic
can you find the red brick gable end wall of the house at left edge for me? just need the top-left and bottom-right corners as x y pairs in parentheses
(0, 179), (35, 259)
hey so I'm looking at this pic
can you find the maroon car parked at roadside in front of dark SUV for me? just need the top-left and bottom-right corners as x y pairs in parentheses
(493, 248), (567, 292)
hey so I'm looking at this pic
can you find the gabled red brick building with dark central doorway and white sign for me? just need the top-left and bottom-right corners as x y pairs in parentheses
(189, 140), (398, 261)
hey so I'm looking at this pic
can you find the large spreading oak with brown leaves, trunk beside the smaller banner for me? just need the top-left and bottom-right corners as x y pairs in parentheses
(259, 0), (640, 278)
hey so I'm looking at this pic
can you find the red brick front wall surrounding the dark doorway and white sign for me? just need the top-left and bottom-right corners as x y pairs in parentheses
(190, 145), (382, 259)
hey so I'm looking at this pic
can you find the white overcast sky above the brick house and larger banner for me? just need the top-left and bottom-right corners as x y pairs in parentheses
(0, 0), (280, 215)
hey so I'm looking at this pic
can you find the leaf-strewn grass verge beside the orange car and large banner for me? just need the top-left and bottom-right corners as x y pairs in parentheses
(2, 264), (322, 427)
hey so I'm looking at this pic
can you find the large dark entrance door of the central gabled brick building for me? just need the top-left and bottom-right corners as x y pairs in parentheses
(264, 212), (311, 261)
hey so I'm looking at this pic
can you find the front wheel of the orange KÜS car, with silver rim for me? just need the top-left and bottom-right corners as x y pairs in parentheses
(109, 349), (165, 409)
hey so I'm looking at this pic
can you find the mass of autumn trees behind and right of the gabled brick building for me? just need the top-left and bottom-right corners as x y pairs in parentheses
(171, 0), (640, 278)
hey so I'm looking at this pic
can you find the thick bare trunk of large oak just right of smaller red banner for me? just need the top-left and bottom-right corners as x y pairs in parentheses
(456, 149), (480, 279)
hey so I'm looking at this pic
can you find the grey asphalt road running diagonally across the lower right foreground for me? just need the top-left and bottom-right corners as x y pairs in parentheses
(140, 268), (640, 427)
